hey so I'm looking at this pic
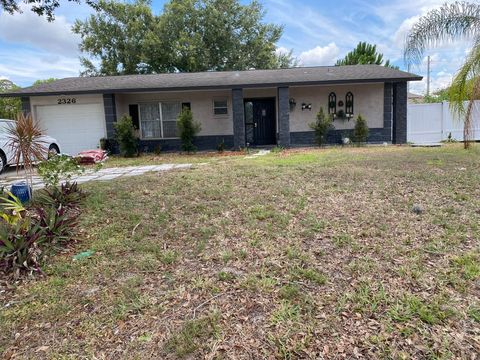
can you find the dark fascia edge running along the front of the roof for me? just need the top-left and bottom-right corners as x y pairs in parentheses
(0, 76), (423, 97)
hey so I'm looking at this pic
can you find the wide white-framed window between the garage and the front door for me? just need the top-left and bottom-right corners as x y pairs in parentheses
(139, 102), (182, 139)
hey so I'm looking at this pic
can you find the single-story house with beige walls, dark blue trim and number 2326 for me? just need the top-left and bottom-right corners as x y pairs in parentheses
(0, 65), (422, 154)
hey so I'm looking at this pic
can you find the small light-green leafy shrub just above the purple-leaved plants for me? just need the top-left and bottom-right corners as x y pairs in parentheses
(38, 154), (84, 187)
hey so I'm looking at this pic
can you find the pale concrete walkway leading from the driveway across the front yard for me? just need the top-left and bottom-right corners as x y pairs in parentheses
(0, 164), (192, 189)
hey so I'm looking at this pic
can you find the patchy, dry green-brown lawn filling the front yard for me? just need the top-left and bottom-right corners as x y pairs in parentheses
(0, 145), (480, 359)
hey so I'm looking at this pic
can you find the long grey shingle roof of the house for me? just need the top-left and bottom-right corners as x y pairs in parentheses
(0, 65), (422, 96)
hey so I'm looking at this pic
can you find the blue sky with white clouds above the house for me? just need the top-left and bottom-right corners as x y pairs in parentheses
(0, 0), (470, 94)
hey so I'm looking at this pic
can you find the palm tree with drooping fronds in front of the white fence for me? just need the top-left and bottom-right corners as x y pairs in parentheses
(404, 2), (480, 149)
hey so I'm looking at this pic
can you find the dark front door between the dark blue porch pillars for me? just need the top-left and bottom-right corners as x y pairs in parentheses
(245, 99), (276, 146)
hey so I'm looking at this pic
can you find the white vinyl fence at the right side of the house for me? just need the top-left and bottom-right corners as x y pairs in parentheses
(407, 100), (480, 144)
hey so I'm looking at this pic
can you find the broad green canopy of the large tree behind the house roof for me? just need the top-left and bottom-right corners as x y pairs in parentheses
(73, 0), (295, 75)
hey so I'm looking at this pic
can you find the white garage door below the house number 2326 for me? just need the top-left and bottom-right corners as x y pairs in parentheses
(36, 104), (105, 155)
